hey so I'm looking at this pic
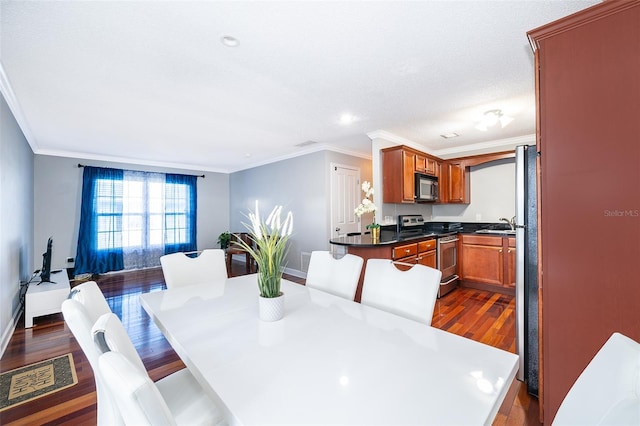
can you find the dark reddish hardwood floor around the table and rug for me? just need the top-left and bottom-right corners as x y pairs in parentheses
(0, 261), (540, 425)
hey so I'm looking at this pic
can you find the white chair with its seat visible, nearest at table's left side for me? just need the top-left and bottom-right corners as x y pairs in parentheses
(92, 313), (225, 425)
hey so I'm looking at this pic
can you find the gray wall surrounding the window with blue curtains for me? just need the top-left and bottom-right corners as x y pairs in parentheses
(33, 155), (229, 269)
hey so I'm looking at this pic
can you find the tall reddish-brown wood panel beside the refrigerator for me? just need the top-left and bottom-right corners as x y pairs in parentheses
(529, 0), (640, 424)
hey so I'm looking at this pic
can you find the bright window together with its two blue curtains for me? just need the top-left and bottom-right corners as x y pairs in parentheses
(76, 167), (197, 273)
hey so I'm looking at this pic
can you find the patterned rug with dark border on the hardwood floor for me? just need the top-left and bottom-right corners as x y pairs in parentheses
(0, 353), (78, 411)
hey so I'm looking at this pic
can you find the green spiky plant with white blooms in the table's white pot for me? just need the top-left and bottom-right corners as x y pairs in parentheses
(233, 201), (293, 298)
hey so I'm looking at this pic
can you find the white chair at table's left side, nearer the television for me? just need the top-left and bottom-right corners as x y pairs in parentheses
(62, 281), (123, 426)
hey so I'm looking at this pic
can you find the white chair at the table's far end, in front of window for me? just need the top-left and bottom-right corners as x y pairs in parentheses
(160, 249), (228, 288)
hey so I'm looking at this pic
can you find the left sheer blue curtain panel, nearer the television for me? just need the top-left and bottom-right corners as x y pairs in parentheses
(75, 166), (124, 274)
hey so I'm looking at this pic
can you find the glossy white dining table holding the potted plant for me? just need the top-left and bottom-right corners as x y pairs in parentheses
(140, 274), (518, 425)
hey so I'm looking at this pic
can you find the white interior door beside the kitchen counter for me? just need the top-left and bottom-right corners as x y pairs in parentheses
(330, 164), (360, 250)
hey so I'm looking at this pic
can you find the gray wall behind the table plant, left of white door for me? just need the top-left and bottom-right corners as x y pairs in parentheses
(229, 151), (371, 276)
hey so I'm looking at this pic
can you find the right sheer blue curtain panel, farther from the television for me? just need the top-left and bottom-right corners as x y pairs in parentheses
(164, 174), (198, 254)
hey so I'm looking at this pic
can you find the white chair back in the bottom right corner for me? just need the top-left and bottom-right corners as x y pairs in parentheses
(553, 333), (640, 426)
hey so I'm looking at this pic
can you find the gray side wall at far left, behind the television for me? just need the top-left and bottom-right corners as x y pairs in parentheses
(0, 97), (33, 355)
